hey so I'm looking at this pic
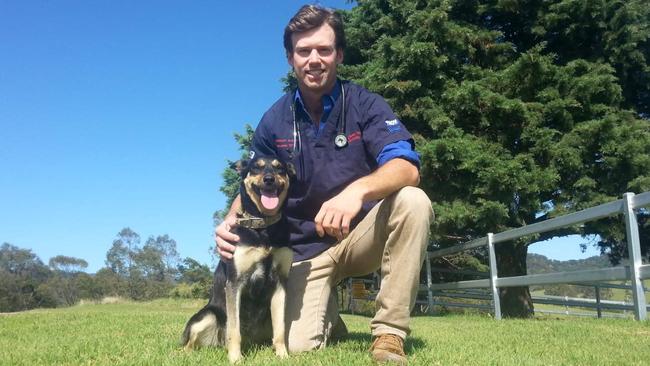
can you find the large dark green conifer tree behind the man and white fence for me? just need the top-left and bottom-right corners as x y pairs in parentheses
(343, 0), (650, 316)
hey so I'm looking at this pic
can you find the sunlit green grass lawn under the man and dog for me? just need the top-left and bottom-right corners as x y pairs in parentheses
(0, 300), (650, 366)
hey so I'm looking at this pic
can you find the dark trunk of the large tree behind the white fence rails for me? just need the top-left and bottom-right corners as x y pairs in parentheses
(495, 243), (535, 318)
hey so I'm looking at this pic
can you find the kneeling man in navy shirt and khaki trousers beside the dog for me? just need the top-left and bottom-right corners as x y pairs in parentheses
(215, 5), (433, 364)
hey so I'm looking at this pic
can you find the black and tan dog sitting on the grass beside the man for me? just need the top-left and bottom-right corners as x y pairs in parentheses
(181, 158), (295, 362)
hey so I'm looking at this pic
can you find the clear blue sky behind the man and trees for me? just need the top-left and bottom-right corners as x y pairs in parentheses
(0, 0), (595, 272)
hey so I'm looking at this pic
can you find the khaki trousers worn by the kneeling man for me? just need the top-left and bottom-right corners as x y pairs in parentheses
(286, 187), (433, 352)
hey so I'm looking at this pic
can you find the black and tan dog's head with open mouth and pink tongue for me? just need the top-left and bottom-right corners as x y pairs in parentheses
(235, 157), (296, 216)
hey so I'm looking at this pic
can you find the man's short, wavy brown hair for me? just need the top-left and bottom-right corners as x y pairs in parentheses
(284, 5), (345, 54)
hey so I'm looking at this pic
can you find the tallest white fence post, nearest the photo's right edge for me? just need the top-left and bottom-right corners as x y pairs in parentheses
(623, 192), (647, 320)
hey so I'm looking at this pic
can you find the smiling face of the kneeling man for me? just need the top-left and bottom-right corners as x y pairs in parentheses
(287, 24), (343, 95)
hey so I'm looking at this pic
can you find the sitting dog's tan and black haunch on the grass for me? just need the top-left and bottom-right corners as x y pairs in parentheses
(181, 304), (226, 350)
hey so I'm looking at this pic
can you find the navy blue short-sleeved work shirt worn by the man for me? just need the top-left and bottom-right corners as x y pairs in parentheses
(251, 81), (419, 261)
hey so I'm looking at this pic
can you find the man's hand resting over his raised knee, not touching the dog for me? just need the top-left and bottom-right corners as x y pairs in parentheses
(314, 187), (363, 241)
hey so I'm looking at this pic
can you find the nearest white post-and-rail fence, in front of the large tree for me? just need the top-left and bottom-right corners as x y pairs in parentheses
(425, 192), (650, 320)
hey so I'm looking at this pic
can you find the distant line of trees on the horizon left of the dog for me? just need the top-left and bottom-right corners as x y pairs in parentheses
(0, 228), (212, 312)
